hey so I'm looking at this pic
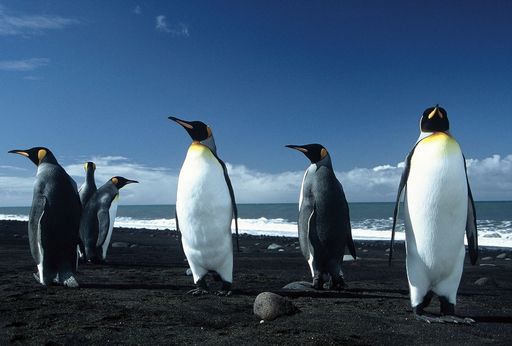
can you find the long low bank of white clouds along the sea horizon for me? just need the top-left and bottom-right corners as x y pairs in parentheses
(0, 155), (512, 206)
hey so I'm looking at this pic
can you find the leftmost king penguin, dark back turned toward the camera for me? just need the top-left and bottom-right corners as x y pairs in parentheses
(9, 147), (81, 287)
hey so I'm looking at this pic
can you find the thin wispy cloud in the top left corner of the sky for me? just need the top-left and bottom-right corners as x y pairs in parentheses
(0, 5), (80, 36)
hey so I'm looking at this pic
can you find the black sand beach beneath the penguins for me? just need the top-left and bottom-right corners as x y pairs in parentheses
(0, 221), (512, 346)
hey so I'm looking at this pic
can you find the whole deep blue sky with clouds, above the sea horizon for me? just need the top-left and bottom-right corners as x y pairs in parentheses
(0, 0), (512, 206)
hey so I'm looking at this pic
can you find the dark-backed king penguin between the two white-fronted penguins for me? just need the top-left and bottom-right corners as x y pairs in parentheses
(286, 144), (356, 290)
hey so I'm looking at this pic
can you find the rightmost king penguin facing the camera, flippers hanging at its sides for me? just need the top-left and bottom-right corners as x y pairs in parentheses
(389, 105), (478, 324)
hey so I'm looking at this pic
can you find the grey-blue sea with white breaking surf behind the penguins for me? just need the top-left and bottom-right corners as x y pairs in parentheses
(0, 201), (512, 248)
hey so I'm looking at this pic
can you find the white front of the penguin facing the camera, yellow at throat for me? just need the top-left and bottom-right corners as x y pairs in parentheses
(404, 133), (468, 306)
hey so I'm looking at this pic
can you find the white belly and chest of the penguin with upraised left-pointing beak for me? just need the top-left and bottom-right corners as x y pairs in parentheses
(176, 143), (233, 282)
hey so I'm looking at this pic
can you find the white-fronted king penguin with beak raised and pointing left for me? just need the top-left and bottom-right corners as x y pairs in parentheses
(169, 117), (238, 296)
